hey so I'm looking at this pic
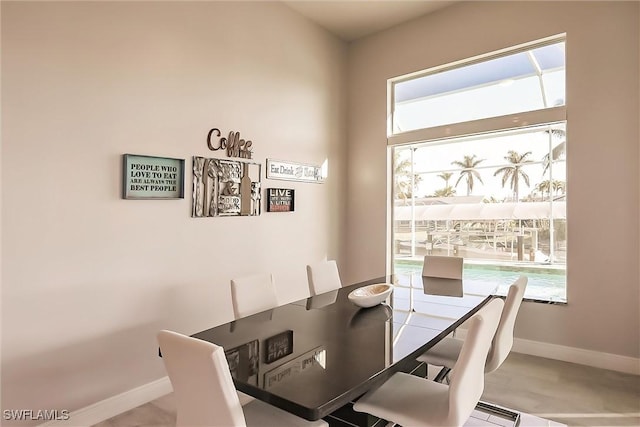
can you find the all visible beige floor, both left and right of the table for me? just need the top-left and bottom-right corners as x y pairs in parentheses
(94, 353), (640, 427)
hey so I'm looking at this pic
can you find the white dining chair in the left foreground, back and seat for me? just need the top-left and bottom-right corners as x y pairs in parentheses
(158, 330), (328, 427)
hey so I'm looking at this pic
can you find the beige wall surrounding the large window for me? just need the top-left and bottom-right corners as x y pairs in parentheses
(345, 2), (640, 358)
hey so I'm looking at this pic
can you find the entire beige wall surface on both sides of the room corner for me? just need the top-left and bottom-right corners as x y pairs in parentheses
(0, 1), (640, 422)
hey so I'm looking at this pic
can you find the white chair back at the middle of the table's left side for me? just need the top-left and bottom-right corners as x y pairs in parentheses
(231, 274), (278, 319)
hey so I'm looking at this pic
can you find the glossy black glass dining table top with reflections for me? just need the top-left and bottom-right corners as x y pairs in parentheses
(192, 277), (491, 420)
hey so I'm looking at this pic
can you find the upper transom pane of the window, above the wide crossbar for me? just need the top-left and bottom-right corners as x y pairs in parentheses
(393, 42), (565, 133)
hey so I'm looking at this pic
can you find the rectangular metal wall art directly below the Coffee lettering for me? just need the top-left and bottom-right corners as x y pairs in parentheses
(191, 157), (262, 218)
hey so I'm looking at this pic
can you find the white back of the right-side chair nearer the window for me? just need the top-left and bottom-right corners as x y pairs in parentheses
(484, 276), (528, 373)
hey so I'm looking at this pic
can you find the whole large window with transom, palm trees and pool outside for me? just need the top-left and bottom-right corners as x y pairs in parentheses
(389, 38), (567, 302)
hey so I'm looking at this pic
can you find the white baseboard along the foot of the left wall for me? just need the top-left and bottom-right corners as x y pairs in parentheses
(39, 377), (173, 427)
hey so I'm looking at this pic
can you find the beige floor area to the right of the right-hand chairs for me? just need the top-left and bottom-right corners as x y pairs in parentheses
(482, 352), (640, 427)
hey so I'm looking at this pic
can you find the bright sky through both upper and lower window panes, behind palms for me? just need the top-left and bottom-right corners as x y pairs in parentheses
(393, 42), (566, 200)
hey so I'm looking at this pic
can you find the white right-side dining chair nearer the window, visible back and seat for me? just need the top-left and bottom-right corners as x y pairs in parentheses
(418, 276), (528, 381)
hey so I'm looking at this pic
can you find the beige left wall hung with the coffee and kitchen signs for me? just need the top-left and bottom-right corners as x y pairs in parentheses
(2, 1), (346, 422)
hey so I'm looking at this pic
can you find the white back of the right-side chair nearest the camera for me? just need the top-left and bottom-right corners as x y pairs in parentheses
(448, 298), (504, 426)
